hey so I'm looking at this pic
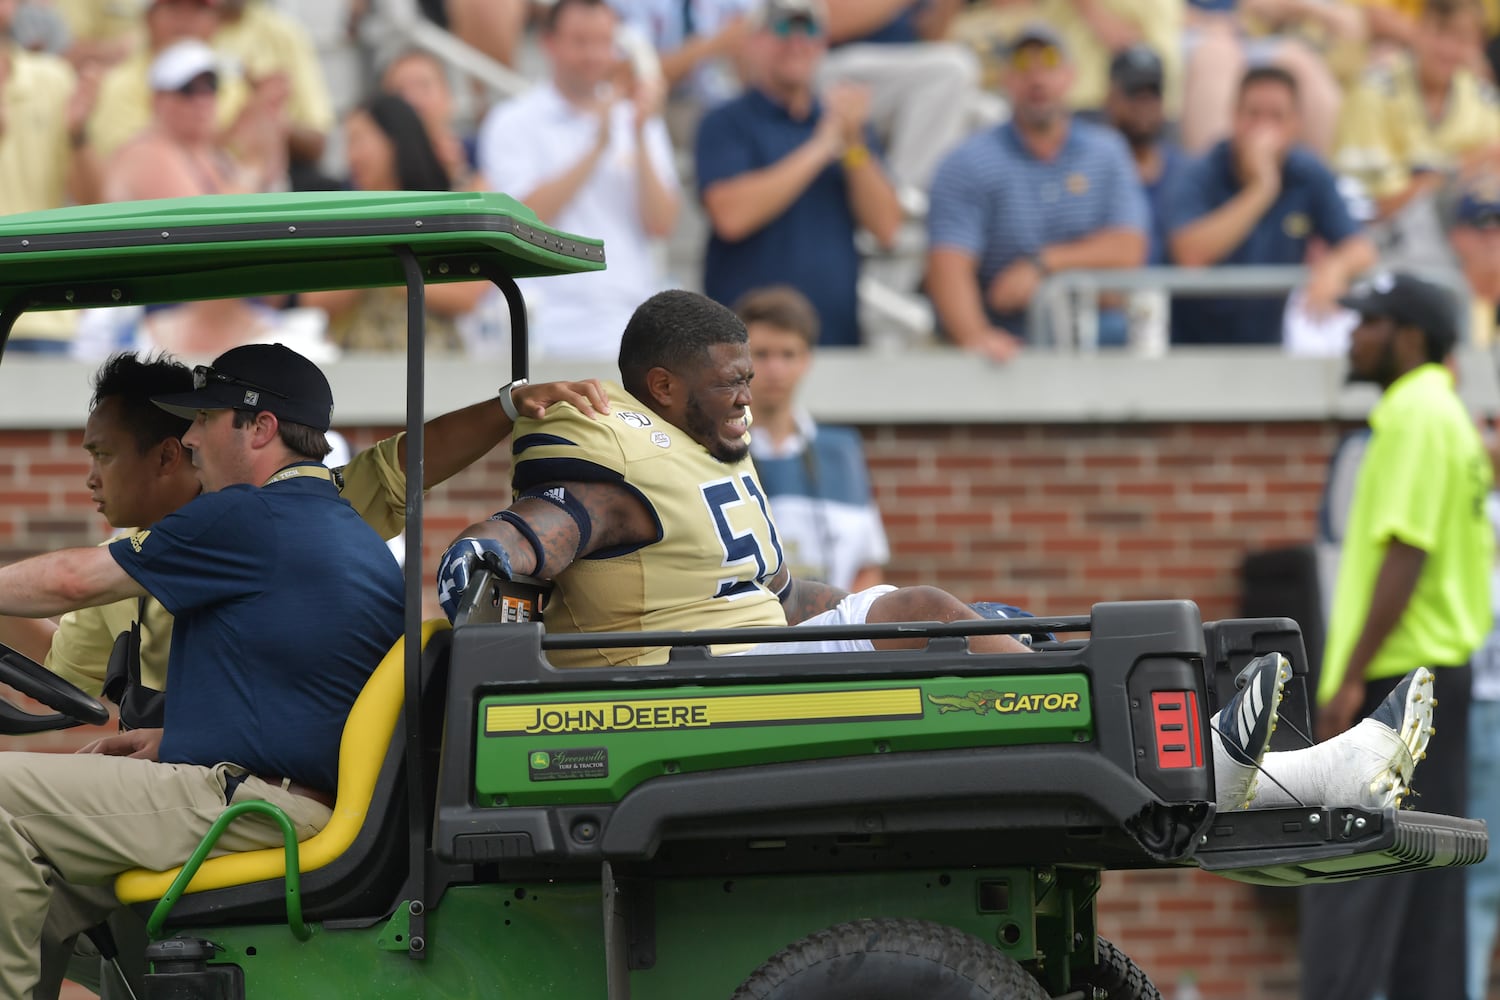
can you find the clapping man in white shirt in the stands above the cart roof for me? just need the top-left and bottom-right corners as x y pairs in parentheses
(479, 0), (680, 358)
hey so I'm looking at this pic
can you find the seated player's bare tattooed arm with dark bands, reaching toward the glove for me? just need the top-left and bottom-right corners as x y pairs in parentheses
(447, 483), (657, 580)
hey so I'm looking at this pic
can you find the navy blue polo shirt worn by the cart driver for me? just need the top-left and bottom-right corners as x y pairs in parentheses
(110, 465), (405, 792)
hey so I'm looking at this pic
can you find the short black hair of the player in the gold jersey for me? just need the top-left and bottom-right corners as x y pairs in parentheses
(620, 289), (750, 400)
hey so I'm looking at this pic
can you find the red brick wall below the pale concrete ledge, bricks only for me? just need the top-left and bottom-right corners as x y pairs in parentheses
(0, 423), (1362, 1000)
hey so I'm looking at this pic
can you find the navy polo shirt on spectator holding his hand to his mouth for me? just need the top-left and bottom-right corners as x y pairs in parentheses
(1166, 141), (1359, 343)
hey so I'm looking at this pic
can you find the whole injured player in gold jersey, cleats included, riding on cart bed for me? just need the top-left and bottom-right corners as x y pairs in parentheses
(438, 291), (1431, 810)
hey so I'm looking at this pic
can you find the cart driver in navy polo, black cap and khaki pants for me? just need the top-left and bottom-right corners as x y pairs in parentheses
(0, 345), (404, 1000)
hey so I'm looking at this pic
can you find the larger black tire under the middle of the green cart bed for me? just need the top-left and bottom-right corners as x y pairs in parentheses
(734, 919), (1047, 1000)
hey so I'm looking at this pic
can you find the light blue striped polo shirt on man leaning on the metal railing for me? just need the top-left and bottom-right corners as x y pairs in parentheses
(927, 118), (1151, 336)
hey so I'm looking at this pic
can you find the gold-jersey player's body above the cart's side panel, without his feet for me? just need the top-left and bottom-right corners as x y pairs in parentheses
(438, 291), (1026, 666)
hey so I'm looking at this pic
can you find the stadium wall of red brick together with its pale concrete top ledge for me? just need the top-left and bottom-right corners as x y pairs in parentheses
(0, 347), (1500, 1000)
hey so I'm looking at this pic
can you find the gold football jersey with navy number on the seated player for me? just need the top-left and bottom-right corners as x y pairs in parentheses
(512, 382), (786, 667)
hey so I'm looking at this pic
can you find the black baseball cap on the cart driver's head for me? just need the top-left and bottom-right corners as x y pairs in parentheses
(152, 343), (333, 430)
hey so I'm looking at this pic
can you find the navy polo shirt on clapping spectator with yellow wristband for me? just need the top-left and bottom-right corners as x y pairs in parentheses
(696, 90), (860, 346)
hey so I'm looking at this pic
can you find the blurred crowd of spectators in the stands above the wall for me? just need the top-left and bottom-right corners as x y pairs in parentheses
(0, 0), (1500, 363)
